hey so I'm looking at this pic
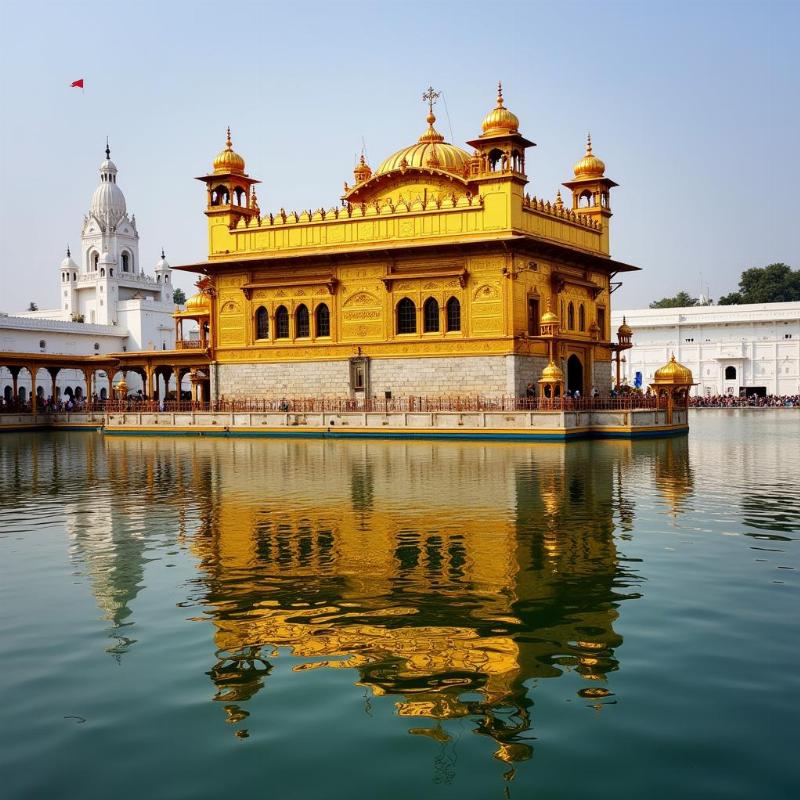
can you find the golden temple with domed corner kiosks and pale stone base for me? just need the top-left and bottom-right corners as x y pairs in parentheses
(182, 86), (637, 399)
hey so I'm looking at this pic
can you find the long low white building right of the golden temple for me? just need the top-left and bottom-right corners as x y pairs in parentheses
(612, 302), (800, 396)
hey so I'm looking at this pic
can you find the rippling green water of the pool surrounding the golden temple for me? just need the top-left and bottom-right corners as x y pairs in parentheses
(0, 411), (800, 798)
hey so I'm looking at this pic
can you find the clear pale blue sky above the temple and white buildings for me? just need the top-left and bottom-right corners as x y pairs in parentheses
(0, 0), (800, 311)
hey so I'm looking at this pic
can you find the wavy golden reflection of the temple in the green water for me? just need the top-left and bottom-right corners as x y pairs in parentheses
(0, 436), (692, 762)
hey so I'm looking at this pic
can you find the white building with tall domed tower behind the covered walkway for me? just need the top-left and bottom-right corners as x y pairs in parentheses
(0, 145), (180, 396)
